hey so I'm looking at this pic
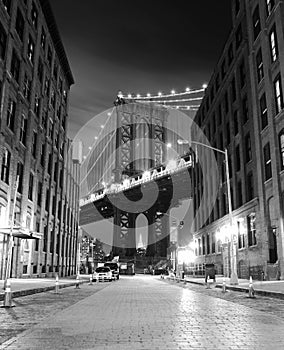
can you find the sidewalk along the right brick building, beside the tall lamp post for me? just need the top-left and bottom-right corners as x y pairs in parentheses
(169, 276), (284, 299)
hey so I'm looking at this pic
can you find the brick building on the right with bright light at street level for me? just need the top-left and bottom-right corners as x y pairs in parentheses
(192, 0), (284, 279)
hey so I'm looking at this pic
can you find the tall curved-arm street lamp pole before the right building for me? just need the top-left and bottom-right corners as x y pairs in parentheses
(177, 139), (238, 285)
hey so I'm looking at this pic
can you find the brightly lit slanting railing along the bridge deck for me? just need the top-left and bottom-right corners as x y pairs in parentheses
(80, 155), (193, 207)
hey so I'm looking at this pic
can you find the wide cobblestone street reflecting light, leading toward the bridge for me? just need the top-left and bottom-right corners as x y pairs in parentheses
(0, 276), (284, 350)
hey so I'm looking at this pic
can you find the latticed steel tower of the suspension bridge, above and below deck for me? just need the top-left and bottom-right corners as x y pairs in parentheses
(112, 103), (169, 257)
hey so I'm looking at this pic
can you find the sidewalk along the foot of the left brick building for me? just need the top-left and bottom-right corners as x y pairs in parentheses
(0, 275), (89, 301)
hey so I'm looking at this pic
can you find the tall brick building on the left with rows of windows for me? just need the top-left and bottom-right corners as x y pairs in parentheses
(0, 0), (79, 278)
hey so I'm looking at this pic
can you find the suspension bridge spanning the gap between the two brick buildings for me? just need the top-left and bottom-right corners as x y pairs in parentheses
(80, 93), (203, 257)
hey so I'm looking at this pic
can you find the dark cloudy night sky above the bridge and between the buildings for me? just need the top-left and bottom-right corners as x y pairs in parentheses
(50, 0), (231, 137)
